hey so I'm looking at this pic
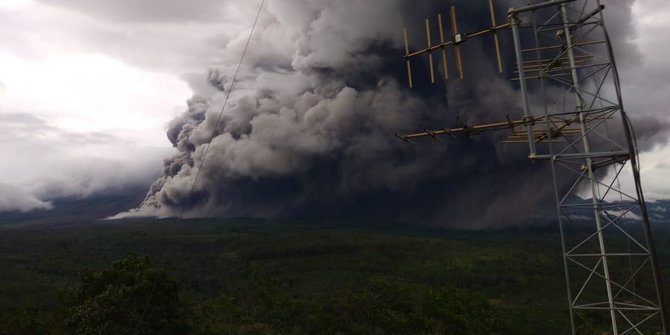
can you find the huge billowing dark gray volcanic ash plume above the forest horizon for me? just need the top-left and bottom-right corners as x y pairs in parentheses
(118, 0), (668, 228)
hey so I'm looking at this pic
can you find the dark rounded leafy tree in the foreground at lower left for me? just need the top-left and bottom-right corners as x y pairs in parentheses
(65, 255), (190, 335)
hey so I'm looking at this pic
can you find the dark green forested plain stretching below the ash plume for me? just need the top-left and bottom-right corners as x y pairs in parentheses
(0, 220), (670, 334)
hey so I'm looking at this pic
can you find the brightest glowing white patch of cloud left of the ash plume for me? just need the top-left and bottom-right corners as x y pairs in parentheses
(0, 52), (191, 146)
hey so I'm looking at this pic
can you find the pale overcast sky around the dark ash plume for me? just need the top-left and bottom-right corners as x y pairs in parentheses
(0, 0), (670, 211)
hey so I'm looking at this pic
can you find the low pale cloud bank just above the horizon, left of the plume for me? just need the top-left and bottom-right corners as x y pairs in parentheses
(0, 113), (172, 205)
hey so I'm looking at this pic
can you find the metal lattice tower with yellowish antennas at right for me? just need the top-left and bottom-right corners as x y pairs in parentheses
(396, 0), (667, 335)
